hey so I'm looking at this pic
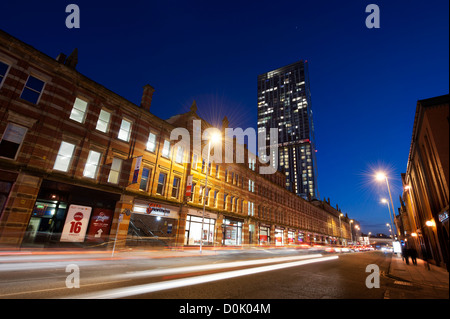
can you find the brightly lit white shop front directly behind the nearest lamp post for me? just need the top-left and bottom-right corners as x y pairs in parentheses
(184, 209), (217, 246)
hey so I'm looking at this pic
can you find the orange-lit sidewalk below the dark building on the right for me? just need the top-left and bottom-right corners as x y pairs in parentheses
(388, 255), (449, 298)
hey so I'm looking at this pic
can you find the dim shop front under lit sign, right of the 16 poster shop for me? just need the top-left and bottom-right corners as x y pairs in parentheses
(126, 199), (179, 247)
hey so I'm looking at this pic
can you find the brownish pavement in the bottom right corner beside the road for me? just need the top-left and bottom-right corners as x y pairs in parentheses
(384, 255), (449, 299)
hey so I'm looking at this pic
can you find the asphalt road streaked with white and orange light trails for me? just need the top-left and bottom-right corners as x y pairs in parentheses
(0, 249), (448, 301)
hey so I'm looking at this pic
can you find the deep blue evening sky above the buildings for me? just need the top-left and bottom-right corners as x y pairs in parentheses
(0, 0), (449, 233)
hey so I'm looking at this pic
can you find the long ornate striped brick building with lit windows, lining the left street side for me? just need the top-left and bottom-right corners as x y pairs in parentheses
(0, 31), (350, 248)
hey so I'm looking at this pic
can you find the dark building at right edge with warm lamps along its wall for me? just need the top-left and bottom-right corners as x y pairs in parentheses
(397, 94), (450, 269)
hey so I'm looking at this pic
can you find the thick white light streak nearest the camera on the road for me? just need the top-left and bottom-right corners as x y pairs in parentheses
(70, 256), (339, 299)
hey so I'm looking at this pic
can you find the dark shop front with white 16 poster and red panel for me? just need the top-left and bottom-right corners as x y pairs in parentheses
(22, 180), (120, 248)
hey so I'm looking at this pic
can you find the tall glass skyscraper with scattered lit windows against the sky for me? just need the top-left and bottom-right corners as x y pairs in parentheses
(258, 61), (319, 199)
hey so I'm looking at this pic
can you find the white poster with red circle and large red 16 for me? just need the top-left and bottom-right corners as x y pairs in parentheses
(60, 205), (92, 243)
